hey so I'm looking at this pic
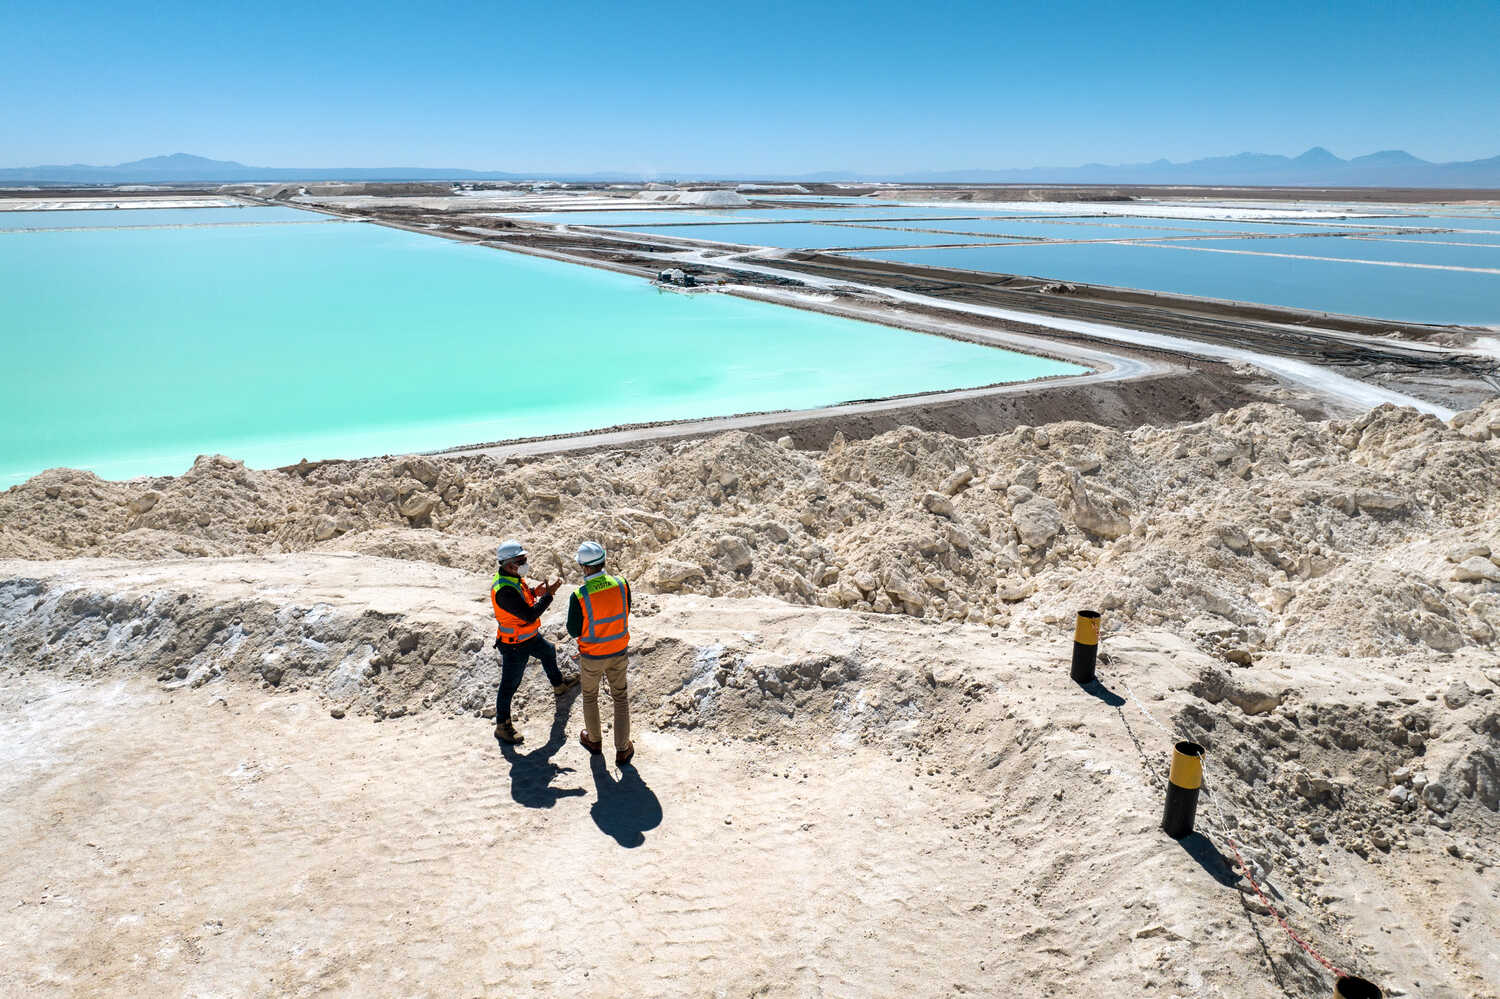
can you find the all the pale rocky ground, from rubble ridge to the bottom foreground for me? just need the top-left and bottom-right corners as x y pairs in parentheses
(0, 407), (1500, 998)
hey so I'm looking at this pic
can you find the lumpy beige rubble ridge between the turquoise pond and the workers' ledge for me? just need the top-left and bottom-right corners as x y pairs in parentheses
(0, 401), (1500, 665)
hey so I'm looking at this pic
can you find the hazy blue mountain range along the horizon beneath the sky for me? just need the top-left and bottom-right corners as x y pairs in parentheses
(0, 146), (1500, 188)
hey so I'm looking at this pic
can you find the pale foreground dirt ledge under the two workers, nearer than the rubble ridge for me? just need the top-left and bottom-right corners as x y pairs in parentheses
(0, 554), (1500, 999)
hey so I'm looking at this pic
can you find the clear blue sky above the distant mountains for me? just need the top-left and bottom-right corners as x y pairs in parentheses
(0, 0), (1500, 176)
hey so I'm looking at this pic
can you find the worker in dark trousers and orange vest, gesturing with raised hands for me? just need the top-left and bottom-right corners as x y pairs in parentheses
(489, 539), (578, 746)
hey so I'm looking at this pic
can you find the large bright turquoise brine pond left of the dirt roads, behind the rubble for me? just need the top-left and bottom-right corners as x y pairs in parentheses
(0, 222), (1085, 486)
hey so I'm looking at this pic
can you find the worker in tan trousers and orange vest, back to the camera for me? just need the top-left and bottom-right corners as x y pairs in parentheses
(567, 542), (636, 767)
